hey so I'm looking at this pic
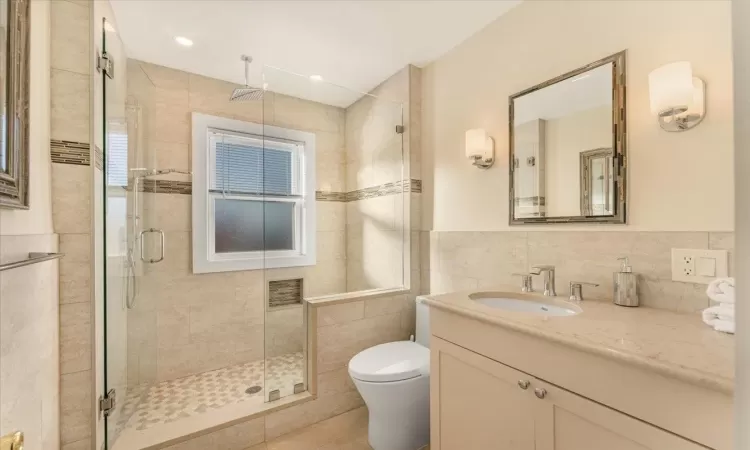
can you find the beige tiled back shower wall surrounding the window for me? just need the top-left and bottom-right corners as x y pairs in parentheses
(128, 60), (346, 386)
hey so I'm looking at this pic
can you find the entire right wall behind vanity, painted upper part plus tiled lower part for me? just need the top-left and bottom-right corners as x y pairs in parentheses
(422, 1), (734, 311)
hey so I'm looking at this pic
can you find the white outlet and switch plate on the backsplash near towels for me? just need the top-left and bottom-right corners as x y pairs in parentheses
(672, 248), (728, 284)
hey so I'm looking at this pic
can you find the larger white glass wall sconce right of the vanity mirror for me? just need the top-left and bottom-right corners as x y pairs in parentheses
(648, 61), (706, 131)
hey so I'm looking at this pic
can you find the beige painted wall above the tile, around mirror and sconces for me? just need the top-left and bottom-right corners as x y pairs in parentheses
(423, 0), (733, 231)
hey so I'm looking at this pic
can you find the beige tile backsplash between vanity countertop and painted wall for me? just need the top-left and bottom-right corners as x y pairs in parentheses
(422, 231), (734, 312)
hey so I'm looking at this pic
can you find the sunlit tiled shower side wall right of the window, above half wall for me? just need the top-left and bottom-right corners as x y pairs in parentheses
(346, 66), (422, 291)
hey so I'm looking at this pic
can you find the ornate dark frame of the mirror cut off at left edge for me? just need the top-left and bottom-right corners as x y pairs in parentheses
(0, 0), (30, 209)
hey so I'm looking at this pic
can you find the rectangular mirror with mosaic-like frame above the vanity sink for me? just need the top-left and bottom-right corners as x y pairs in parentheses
(509, 52), (626, 225)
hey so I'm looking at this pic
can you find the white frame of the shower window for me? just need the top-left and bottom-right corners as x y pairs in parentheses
(192, 113), (316, 273)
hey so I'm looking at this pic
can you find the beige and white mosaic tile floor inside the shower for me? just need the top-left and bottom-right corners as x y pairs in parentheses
(118, 352), (304, 430)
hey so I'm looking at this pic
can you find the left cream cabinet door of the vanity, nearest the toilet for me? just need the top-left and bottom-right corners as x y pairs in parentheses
(430, 336), (536, 450)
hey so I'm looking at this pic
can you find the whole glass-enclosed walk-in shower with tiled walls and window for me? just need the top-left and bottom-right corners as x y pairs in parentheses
(99, 14), (412, 450)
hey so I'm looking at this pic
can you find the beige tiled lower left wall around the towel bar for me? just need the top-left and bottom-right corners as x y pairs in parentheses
(0, 237), (59, 450)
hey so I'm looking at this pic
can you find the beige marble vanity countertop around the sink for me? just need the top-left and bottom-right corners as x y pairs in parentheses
(425, 288), (734, 394)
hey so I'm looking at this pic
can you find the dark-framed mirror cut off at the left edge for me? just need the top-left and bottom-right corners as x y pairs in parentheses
(0, 0), (29, 209)
